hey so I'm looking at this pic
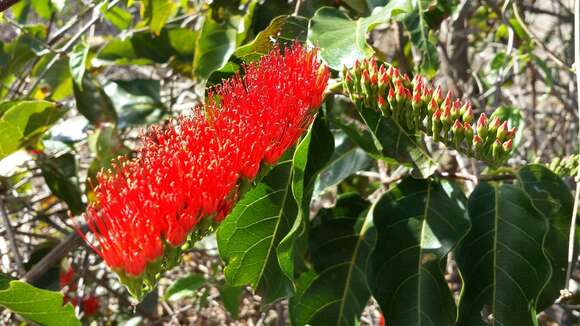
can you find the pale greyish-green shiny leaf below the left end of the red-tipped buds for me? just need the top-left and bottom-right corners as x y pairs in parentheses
(313, 130), (371, 196)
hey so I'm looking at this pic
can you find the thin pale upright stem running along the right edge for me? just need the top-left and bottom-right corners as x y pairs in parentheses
(566, 0), (580, 289)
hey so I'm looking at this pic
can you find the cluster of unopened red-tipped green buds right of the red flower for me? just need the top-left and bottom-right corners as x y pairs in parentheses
(342, 58), (516, 164)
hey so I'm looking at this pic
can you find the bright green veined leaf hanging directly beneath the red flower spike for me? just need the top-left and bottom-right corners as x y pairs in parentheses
(217, 159), (298, 303)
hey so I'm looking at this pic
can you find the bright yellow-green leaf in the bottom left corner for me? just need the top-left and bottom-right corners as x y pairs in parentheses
(0, 274), (81, 326)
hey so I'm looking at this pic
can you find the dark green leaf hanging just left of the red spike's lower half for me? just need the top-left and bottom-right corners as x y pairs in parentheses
(40, 153), (85, 215)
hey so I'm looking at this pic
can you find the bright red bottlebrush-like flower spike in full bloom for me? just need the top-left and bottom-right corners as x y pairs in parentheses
(79, 44), (328, 276)
